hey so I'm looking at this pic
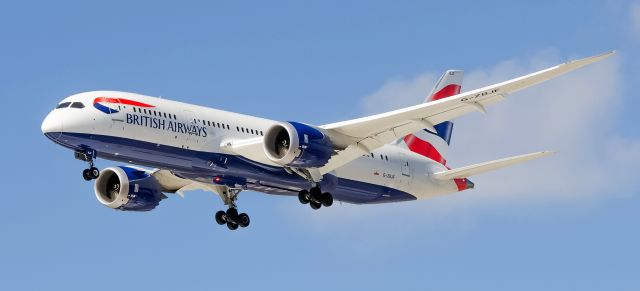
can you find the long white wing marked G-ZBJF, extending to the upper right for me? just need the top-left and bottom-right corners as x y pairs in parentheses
(319, 51), (615, 174)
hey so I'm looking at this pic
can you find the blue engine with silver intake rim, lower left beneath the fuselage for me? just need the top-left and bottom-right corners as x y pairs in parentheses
(94, 167), (167, 211)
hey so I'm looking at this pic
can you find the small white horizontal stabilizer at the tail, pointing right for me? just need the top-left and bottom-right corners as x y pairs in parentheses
(433, 151), (553, 180)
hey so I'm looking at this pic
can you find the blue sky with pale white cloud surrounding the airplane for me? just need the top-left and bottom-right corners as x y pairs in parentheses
(0, 1), (640, 290)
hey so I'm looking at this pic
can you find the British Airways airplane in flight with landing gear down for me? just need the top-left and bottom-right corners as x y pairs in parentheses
(41, 51), (615, 230)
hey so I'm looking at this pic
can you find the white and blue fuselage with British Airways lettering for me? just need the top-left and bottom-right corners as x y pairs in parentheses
(42, 91), (458, 203)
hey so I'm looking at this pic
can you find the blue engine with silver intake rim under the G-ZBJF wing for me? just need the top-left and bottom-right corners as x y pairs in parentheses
(264, 122), (334, 168)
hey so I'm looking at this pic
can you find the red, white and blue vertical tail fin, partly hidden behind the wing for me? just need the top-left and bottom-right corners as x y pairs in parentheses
(403, 70), (464, 165)
